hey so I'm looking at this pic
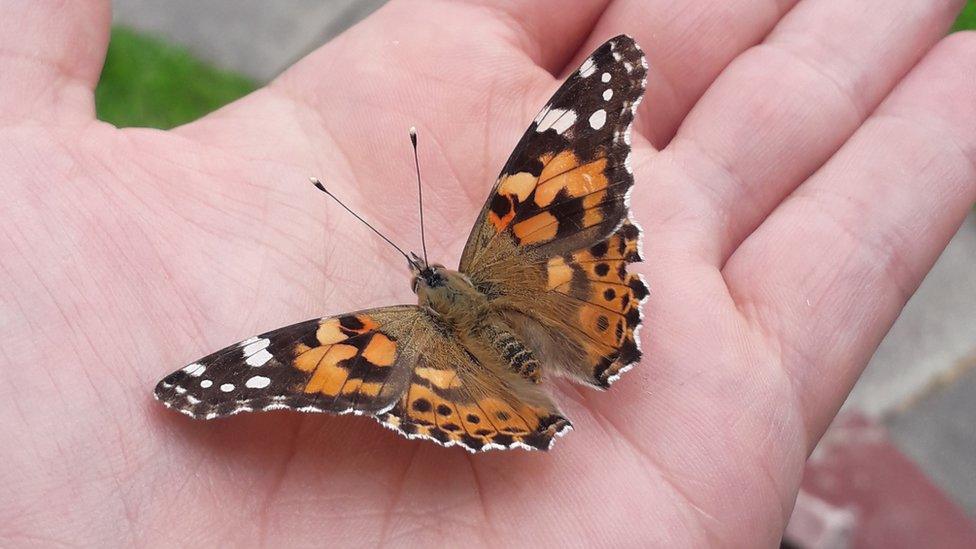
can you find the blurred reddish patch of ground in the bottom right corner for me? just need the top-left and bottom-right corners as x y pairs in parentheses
(784, 413), (976, 549)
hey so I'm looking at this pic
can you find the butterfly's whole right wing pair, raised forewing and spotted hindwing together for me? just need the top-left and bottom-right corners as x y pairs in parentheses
(459, 35), (647, 387)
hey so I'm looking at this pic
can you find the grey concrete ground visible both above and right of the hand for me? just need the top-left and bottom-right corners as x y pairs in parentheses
(114, 0), (976, 517)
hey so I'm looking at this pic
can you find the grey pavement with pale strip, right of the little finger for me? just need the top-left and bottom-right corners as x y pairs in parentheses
(845, 214), (976, 518)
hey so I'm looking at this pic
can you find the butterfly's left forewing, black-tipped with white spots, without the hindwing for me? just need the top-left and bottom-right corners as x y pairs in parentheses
(155, 305), (420, 419)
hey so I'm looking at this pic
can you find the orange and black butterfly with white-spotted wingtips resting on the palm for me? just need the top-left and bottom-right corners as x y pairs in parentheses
(155, 35), (648, 452)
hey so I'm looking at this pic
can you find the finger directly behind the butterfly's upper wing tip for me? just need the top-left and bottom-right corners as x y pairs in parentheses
(579, 0), (796, 149)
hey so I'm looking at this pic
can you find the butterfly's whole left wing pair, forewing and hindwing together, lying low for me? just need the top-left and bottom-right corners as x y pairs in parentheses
(155, 305), (569, 451)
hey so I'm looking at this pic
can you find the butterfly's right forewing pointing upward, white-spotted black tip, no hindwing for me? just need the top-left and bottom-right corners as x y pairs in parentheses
(460, 36), (647, 266)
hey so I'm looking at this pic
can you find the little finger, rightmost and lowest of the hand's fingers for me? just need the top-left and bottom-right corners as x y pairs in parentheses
(724, 33), (976, 441)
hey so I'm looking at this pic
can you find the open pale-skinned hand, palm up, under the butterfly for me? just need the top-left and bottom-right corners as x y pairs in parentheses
(0, 0), (976, 547)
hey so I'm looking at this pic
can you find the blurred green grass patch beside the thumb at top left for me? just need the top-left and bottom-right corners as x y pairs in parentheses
(95, 27), (257, 128)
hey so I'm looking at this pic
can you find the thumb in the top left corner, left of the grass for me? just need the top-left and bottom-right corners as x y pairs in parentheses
(0, 0), (111, 122)
